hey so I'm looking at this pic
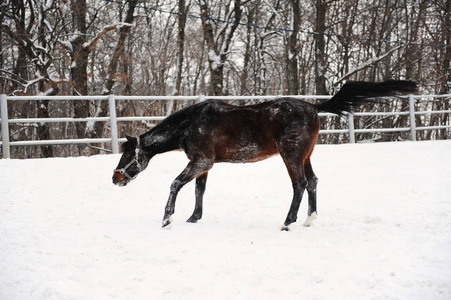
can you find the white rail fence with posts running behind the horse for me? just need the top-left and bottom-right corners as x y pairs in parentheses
(0, 94), (451, 158)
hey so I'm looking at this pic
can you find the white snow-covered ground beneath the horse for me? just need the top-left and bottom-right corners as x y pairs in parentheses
(0, 141), (451, 300)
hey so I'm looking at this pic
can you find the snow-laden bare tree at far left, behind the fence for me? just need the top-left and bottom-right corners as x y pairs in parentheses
(2, 0), (69, 157)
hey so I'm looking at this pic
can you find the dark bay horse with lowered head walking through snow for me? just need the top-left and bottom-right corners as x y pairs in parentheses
(113, 80), (416, 231)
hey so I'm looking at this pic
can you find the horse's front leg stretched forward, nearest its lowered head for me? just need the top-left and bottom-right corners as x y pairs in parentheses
(162, 159), (213, 227)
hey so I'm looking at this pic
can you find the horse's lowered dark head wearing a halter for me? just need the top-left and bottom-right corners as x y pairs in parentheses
(113, 135), (149, 186)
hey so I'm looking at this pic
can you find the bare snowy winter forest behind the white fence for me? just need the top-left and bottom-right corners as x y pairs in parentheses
(0, 0), (451, 157)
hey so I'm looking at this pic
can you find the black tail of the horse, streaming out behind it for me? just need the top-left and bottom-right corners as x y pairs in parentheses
(316, 80), (417, 116)
